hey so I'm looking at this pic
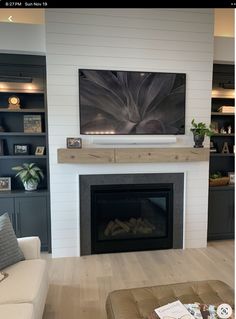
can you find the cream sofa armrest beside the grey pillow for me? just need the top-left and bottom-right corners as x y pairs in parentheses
(17, 237), (41, 259)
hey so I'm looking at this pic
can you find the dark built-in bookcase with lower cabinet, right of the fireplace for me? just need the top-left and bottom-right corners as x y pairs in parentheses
(207, 63), (235, 240)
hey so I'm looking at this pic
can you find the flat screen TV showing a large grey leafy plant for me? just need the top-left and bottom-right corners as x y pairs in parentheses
(79, 69), (186, 135)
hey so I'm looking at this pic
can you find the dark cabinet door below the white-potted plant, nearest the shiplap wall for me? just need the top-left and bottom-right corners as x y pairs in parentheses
(15, 196), (48, 248)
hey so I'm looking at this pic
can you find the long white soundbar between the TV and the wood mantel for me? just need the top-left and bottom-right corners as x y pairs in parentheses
(91, 135), (177, 145)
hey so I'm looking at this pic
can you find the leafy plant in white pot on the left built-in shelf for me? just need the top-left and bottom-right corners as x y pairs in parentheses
(12, 163), (44, 191)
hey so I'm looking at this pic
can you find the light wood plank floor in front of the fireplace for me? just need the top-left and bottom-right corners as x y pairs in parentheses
(43, 240), (234, 319)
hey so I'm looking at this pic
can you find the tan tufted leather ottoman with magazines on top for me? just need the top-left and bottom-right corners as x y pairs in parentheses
(106, 280), (234, 319)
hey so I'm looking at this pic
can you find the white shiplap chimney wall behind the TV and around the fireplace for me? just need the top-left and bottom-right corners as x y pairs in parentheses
(46, 9), (213, 256)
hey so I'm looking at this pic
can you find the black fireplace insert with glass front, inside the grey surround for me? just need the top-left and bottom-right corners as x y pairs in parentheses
(90, 183), (173, 254)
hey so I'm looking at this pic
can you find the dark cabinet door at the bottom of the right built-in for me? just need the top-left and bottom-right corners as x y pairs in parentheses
(208, 189), (234, 239)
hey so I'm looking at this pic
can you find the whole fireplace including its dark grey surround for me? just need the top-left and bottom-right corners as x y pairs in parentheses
(80, 173), (184, 255)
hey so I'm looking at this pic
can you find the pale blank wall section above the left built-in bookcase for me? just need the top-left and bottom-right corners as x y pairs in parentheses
(0, 22), (45, 55)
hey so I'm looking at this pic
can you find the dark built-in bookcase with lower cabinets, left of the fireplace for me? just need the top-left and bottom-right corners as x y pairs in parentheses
(0, 53), (51, 252)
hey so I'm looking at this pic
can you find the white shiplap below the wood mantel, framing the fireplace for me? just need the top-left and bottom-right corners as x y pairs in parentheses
(51, 162), (208, 257)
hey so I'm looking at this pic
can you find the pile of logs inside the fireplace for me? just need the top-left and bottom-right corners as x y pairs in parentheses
(104, 218), (156, 236)
